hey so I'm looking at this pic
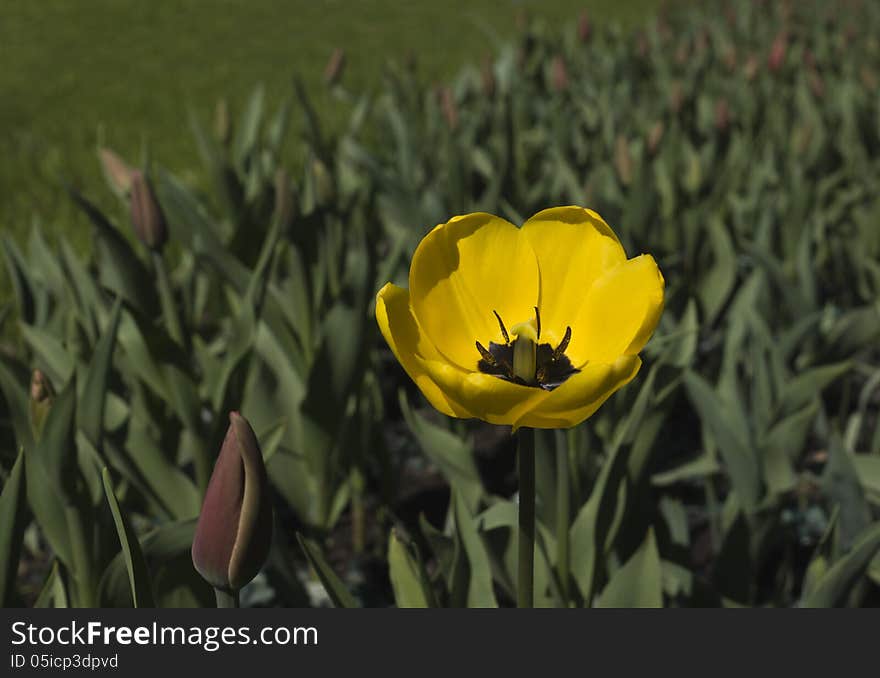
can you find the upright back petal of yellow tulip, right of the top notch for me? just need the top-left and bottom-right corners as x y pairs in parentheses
(522, 207), (626, 345)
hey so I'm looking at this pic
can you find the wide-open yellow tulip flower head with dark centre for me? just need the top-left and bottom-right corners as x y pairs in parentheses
(376, 207), (664, 429)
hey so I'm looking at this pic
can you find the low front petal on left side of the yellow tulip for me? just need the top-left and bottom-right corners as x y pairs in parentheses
(424, 360), (550, 426)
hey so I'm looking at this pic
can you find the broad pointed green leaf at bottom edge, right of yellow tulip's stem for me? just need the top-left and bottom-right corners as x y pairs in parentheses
(596, 529), (663, 608)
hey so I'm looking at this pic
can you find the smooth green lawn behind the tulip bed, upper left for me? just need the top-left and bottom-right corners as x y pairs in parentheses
(0, 0), (659, 260)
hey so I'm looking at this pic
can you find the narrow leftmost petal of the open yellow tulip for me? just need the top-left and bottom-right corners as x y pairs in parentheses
(376, 283), (471, 418)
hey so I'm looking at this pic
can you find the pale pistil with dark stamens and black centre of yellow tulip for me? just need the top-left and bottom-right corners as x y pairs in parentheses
(476, 307), (580, 391)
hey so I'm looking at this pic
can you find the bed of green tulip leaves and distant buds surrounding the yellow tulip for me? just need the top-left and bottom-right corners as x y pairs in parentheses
(0, 0), (880, 606)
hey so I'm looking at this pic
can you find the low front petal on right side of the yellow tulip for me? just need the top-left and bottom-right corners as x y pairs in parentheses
(516, 355), (642, 428)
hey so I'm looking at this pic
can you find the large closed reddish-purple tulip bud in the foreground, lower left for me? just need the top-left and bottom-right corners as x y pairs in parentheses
(192, 412), (272, 592)
